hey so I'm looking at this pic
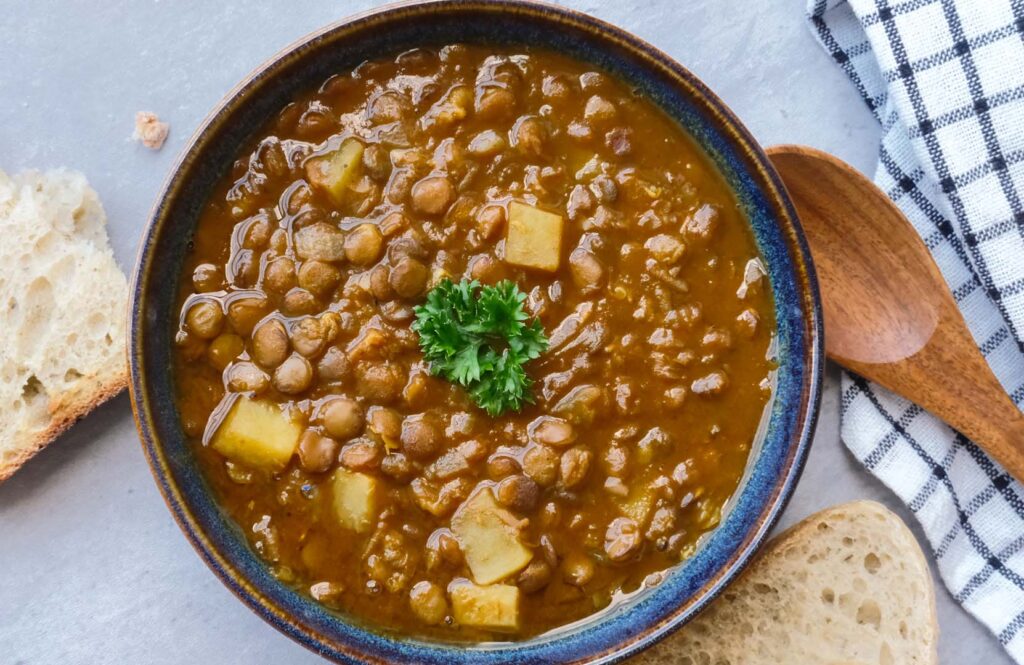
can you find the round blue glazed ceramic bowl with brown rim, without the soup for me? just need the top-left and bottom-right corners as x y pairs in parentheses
(129, 0), (823, 664)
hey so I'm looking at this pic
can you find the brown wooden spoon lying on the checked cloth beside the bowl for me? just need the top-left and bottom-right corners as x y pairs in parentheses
(768, 146), (1024, 482)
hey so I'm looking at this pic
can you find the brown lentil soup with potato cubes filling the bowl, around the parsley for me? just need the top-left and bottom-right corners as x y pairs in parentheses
(174, 45), (775, 641)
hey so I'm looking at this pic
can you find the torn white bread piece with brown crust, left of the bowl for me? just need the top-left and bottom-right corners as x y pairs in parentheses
(0, 170), (128, 481)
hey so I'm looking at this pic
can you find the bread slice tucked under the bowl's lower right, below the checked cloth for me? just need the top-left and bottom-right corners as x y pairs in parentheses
(632, 501), (938, 665)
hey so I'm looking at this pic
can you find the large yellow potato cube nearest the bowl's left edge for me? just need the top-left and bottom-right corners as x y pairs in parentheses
(210, 397), (302, 471)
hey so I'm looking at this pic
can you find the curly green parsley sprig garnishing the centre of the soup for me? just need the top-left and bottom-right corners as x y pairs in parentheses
(413, 280), (548, 416)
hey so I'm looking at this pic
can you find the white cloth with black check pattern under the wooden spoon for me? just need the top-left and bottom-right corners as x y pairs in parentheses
(809, 0), (1024, 665)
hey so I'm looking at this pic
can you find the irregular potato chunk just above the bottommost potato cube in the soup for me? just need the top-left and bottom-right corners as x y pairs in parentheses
(452, 488), (534, 584)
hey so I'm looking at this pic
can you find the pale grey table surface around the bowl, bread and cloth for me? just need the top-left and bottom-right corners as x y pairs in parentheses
(0, 0), (1011, 665)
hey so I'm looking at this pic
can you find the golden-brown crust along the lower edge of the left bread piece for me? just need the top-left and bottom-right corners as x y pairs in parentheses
(0, 368), (128, 483)
